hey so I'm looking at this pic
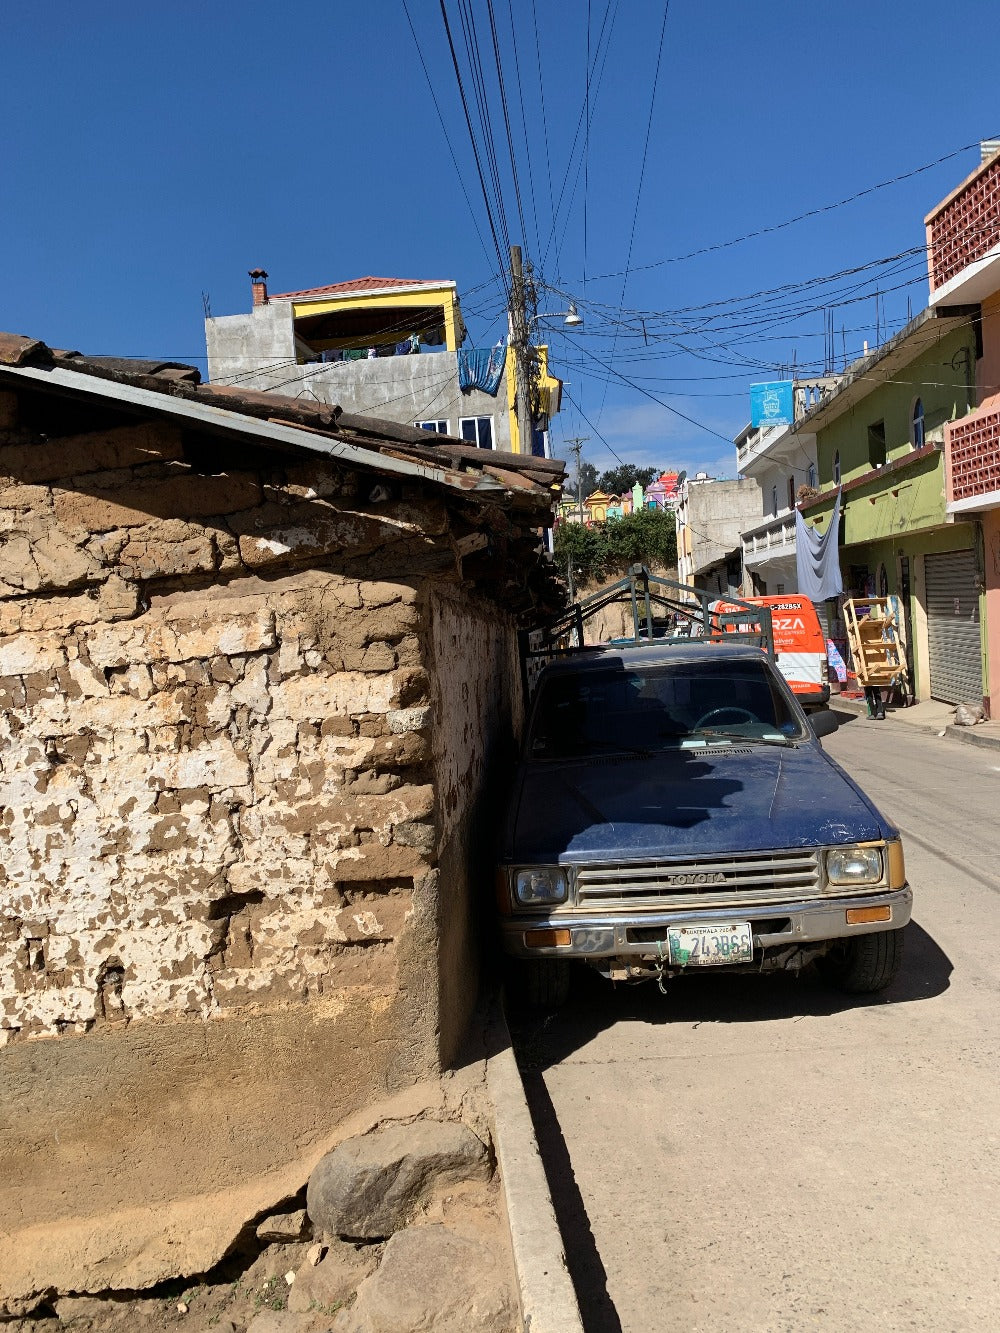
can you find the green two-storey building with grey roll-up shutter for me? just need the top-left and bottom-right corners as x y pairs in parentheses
(796, 308), (985, 704)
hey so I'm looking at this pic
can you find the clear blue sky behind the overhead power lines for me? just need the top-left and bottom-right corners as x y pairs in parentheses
(0, 0), (1000, 475)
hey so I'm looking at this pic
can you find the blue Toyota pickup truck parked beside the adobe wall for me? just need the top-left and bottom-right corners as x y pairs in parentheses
(497, 640), (912, 1005)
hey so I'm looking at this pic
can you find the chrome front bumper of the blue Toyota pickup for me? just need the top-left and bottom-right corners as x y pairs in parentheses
(500, 885), (913, 960)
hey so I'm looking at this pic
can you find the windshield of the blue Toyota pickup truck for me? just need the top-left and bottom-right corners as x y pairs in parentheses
(528, 656), (807, 760)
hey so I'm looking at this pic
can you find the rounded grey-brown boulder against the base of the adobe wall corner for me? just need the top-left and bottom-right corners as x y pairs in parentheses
(305, 1120), (491, 1240)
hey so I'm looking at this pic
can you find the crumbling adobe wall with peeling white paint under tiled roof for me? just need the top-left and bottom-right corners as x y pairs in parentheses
(0, 397), (528, 1296)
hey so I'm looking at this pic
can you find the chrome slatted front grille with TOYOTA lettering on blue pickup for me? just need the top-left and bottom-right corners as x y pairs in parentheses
(576, 849), (821, 910)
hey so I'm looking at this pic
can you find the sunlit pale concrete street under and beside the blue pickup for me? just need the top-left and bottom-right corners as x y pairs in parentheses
(516, 718), (1000, 1333)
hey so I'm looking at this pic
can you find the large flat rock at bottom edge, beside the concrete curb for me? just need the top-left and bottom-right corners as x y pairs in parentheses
(333, 1224), (519, 1333)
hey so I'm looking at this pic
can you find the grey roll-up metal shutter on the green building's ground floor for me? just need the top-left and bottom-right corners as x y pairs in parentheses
(924, 551), (983, 704)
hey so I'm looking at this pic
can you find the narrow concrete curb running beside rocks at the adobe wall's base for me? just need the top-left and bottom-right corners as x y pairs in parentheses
(487, 1002), (584, 1333)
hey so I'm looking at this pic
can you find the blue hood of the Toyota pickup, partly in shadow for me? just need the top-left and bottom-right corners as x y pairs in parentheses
(504, 744), (895, 865)
